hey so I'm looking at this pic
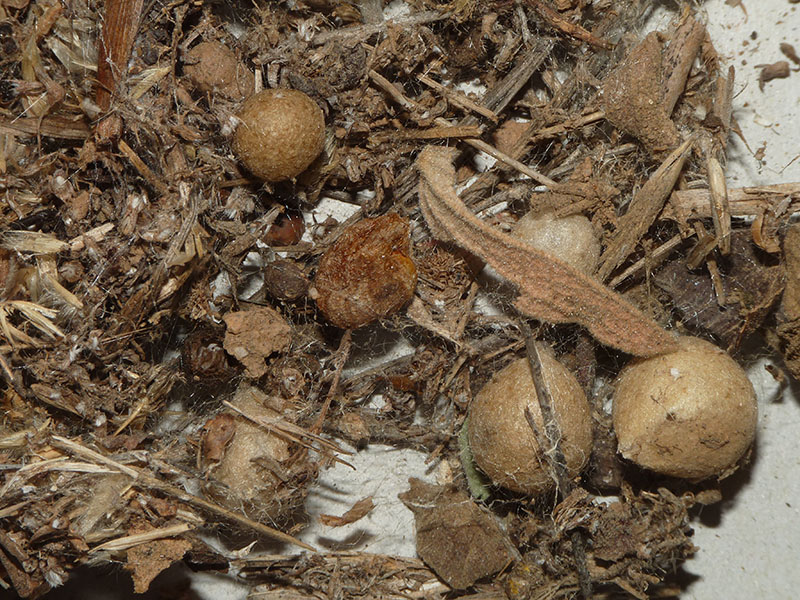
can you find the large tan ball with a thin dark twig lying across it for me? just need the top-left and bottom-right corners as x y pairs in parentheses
(469, 352), (592, 495)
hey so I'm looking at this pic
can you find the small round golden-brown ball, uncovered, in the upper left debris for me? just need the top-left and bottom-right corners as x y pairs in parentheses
(233, 89), (325, 182)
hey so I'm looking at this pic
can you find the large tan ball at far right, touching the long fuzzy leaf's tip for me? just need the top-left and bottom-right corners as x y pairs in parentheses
(613, 337), (758, 479)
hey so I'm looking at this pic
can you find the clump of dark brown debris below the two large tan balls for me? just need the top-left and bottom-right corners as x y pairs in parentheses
(504, 486), (696, 600)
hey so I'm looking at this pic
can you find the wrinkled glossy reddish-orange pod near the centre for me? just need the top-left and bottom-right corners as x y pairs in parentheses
(314, 213), (417, 329)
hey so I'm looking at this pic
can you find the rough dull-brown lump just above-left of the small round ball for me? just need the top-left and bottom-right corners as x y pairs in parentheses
(183, 42), (255, 100)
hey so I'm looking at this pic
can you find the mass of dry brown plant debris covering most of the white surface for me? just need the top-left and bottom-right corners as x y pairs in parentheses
(0, 0), (800, 599)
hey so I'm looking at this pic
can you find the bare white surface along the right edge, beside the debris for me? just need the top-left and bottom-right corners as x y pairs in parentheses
(683, 0), (800, 600)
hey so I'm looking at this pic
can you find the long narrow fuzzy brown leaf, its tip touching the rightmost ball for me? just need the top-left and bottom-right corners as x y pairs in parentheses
(417, 146), (675, 356)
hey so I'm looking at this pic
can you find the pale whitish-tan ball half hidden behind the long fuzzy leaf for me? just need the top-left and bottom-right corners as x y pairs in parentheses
(513, 212), (601, 275)
